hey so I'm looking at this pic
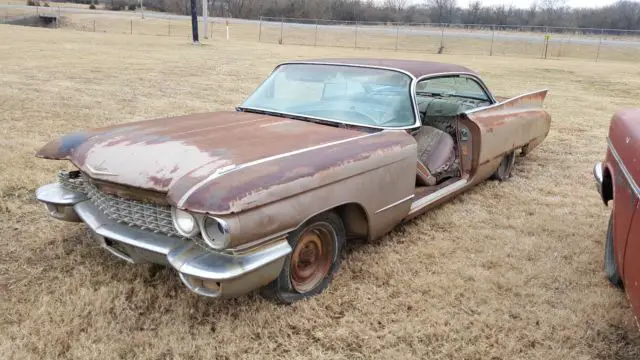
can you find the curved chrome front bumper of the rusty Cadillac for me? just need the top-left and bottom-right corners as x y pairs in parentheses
(36, 183), (291, 297)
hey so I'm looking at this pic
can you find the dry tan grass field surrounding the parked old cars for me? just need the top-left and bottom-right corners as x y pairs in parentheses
(0, 25), (640, 360)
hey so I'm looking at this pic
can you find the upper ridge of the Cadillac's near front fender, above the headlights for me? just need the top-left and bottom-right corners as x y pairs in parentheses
(168, 131), (416, 215)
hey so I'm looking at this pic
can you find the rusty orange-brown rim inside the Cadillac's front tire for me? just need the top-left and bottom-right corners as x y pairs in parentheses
(291, 224), (334, 293)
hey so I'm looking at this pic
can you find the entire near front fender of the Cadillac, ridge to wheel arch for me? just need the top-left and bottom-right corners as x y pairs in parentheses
(169, 131), (417, 247)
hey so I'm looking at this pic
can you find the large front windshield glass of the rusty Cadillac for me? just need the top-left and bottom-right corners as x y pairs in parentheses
(240, 64), (415, 128)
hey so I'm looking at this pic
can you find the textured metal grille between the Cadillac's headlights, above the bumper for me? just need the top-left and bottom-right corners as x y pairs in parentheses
(57, 172), (180, 236)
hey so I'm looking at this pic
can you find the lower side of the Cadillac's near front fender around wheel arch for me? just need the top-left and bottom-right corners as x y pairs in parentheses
(232, 150), (416, 248)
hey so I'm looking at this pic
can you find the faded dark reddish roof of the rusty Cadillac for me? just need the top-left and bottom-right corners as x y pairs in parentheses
(288, 58), (477, 78)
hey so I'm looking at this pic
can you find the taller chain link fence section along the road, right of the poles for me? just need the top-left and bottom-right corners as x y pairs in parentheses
(258, 17), (640, 61)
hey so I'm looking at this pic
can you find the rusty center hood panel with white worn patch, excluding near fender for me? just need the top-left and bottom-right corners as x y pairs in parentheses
(37, 111), (362, 192)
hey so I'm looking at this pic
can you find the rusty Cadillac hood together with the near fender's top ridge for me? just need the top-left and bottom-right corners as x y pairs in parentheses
(36, 111), (416, 215)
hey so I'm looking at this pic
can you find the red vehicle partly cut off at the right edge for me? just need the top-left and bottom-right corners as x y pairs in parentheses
(593, 108), (640, 320)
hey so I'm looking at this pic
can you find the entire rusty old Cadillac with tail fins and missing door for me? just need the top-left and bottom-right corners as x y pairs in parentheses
(36, 59), (551, 303)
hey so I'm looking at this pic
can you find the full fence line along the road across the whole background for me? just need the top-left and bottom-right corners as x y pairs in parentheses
(0, 6), (640, 62)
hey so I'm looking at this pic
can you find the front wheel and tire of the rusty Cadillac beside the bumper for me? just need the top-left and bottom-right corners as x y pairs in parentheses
(260, 212), (346, 304)
